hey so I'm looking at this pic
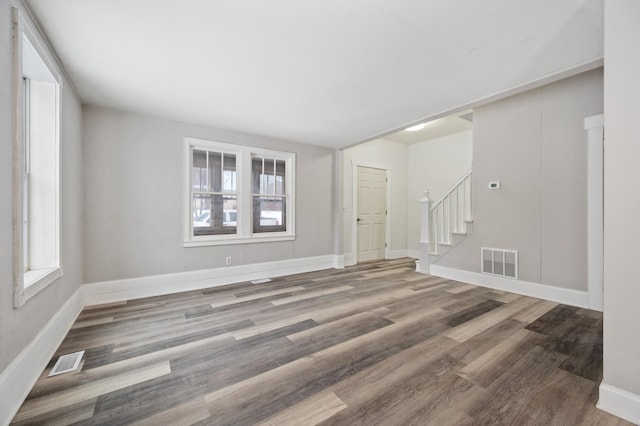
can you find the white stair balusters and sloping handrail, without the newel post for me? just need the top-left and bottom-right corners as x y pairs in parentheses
(429, 170), (472, 254)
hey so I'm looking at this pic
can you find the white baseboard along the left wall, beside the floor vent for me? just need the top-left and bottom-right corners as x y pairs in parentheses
(0, 287), (84, 425)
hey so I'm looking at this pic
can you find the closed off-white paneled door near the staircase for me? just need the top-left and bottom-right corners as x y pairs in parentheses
(356, 166), (387, 262)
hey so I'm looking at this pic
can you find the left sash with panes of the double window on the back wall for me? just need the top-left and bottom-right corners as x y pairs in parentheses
(192, 149), (238, 236)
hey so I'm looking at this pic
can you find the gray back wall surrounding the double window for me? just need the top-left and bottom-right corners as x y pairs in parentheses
(84, 106), (334, 282)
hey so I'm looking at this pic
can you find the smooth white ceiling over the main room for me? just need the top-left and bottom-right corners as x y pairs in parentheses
(28, 0), (603, 147)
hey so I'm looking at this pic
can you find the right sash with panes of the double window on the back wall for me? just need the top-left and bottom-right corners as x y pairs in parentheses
(251, 157), (287, 233)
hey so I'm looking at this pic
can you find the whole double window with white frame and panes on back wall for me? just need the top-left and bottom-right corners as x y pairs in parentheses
(184, 138), (295, 247)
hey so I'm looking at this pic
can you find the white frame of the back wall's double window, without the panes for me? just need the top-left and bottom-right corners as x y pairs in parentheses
(182, 137), (296, 247)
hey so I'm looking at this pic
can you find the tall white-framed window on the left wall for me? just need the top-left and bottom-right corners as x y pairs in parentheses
(12, 8), (63, 308)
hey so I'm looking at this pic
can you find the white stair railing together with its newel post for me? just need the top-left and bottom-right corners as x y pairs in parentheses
(416, 170), (473, 273)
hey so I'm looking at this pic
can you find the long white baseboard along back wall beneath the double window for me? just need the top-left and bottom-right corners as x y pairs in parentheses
(82, 255), (345, 306)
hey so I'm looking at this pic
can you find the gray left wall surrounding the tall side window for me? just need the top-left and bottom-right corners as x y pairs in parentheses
(0, 0), (83, 371)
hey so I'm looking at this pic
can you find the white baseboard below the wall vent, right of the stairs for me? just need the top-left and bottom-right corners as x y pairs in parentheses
(429, 264), (589, 309)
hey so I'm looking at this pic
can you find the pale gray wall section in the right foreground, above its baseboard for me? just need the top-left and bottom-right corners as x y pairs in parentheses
(603, 0), (640, 400)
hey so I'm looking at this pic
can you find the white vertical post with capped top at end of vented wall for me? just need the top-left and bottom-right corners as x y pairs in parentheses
(584, 114), (604, 311)
